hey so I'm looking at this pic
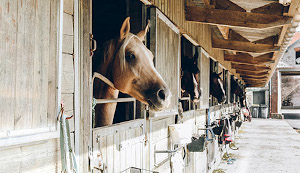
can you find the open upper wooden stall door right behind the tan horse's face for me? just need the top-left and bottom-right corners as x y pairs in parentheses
(150, 8), (180, 115)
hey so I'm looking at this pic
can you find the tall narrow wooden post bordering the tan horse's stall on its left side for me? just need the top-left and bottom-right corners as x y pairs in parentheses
(78, 0), (92, 172)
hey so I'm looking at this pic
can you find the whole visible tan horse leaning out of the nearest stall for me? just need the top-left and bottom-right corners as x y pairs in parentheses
(93, 17), (171, 127)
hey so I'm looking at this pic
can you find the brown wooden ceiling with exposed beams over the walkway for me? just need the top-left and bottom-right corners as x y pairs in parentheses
(185, 0), (299, 87)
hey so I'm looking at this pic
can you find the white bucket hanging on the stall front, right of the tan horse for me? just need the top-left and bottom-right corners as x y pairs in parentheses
(169, 124), (192, 145)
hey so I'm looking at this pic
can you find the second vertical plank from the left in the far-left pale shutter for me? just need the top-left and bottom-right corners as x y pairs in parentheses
(14, 0), (35, 129)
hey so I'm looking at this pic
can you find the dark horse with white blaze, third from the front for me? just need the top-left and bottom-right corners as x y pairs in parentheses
(209, 72), (226, 103)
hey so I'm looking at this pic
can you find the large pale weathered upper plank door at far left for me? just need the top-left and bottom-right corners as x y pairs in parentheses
(0, 0), (58, 144)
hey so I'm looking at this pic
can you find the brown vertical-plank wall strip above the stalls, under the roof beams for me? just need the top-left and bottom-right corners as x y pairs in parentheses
(148, 0), (244, 81)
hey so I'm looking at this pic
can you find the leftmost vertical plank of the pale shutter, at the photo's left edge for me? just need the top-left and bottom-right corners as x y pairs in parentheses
(0, 0), (18, 130)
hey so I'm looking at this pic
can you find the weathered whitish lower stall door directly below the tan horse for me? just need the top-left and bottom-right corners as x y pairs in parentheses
(93, 119), (146, 173)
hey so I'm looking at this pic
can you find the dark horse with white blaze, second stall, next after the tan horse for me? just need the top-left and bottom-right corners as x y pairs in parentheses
(181, 50), (201, 103)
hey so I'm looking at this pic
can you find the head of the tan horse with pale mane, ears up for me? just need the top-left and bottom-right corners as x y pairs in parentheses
(99, 17), (171, 111)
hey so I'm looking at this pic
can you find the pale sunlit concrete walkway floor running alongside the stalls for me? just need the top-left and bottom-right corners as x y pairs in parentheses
(214, 118), (300, 173)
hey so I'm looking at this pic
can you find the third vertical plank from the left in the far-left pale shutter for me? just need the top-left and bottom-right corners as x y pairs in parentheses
(32, 1), (50, 127)
